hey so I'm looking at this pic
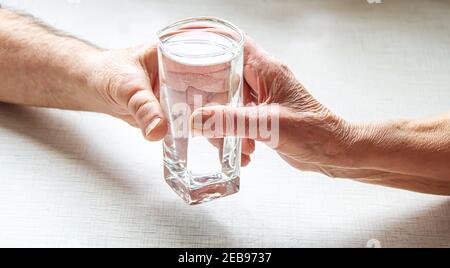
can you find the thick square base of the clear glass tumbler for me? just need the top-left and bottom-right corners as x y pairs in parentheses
(164, 167), (240, 205)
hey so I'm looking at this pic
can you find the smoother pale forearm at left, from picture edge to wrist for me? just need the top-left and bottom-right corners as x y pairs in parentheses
(0, 8), (103, 110)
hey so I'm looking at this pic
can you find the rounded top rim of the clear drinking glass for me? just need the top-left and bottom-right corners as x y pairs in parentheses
(156, 16), (245, 59)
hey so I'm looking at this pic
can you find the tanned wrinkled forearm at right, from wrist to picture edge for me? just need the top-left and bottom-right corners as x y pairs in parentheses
(351, 114), (450, 184)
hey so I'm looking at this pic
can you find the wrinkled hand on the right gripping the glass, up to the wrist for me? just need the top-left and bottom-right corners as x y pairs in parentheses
(193, 40), (372, 177)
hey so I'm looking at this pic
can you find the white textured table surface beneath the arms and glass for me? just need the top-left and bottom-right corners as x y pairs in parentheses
(0, 0), (450, 247)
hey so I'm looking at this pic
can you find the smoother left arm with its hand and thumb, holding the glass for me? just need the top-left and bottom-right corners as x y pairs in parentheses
(0, 7), (167, 140)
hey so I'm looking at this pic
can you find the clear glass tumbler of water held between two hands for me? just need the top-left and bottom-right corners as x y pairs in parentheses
(158, 17), (244, 204)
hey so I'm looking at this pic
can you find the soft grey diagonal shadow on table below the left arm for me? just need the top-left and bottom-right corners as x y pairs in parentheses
(0, 103), (231, 247)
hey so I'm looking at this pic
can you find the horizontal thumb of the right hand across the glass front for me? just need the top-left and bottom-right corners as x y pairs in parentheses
(191, 104), (280, 146)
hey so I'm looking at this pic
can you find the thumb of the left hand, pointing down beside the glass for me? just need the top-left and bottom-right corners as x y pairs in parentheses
(127, 89), (167, 141)
